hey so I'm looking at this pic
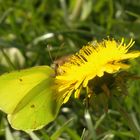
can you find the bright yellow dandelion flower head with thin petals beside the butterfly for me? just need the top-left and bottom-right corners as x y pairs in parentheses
(56, 39), (140, 103)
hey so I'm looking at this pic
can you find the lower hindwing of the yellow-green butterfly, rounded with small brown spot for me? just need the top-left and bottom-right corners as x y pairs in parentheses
(8, 79), (62, 131)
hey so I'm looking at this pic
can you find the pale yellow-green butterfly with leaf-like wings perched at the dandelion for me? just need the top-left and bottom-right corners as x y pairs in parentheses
(0, 66), (62, 132)
